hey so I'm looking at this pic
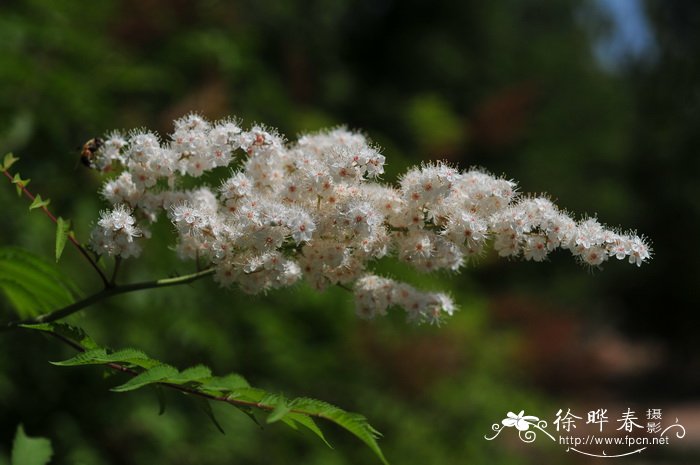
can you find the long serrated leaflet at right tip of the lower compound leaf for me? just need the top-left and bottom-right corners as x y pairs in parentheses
(290, 398), (389, 465)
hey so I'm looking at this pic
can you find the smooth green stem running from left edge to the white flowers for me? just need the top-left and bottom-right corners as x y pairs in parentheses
(0, 268), (214, 331)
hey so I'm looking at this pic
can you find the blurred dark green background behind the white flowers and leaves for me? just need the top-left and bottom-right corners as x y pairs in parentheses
(0, 0), (700, 465)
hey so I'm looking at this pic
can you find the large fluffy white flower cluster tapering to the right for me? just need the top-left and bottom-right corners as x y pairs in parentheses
(87, 114), (650, 321)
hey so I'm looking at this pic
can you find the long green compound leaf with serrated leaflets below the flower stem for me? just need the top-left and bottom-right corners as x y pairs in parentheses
(23, 323), (388, 464)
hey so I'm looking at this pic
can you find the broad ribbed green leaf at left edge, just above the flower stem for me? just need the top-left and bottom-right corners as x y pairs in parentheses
(0, 247), (79, 318)
